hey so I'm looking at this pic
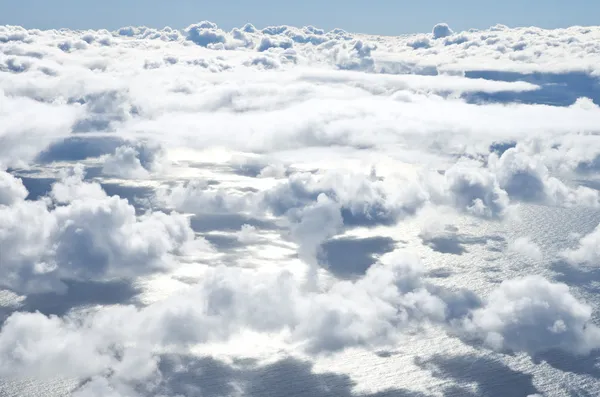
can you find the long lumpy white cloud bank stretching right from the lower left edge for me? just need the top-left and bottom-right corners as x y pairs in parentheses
(0, 252), (445, 383)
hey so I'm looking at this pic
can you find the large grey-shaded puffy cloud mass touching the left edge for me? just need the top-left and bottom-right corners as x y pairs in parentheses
(0, 170), (208, 293)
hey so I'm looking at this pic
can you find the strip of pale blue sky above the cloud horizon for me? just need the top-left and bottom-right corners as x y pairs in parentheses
(0, 0), (600, 35)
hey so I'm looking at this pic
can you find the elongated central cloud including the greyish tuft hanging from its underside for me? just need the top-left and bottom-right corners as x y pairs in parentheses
(158, 166), (428, 270)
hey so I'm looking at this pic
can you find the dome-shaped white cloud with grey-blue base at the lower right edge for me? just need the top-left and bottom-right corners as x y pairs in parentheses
(462, 276), (600, 355)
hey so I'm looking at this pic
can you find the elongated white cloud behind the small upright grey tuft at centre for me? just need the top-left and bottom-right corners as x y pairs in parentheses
(163, 166), (429, 234)
